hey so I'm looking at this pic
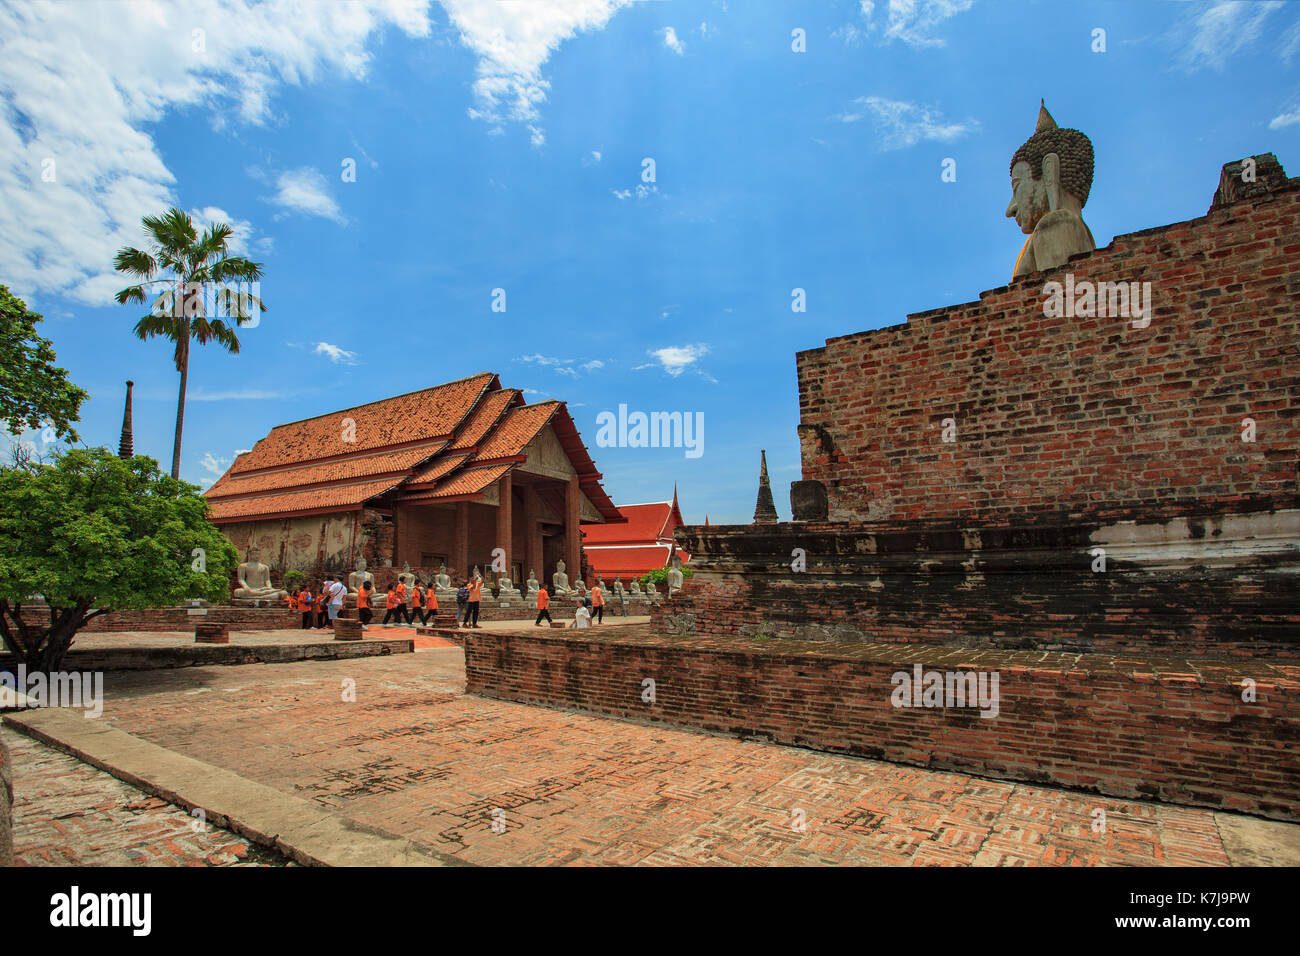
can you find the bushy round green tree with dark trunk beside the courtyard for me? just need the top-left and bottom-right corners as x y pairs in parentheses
(0, 449), (238, 674)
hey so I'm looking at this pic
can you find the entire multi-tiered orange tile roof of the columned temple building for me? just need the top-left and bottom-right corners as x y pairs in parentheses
(205, 372), (623, 528)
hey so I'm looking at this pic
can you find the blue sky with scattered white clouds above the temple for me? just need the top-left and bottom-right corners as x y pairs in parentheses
(0, 0), (1300, 523)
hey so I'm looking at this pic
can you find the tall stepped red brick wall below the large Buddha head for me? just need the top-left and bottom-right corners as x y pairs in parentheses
(797, 179), (1300, 523)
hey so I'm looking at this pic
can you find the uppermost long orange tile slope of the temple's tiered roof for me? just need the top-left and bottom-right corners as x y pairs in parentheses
(231, 372), (497, 473)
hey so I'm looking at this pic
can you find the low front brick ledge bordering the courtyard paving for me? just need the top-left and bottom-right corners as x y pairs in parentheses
(465, 628), (1300, 826)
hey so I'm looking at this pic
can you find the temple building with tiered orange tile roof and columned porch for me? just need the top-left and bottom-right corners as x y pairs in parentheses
(207, 372), (624, 583)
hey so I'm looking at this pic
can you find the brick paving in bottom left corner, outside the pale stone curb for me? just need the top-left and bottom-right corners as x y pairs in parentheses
(0, 730), (291, 866)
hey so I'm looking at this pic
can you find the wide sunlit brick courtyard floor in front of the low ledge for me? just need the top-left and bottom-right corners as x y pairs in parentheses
(10, 646), (1279, 866)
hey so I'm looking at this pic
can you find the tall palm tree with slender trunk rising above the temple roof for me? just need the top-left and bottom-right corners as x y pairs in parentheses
(113, 207), (267, 479)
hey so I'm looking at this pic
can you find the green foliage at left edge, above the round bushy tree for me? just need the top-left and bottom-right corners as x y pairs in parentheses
(0, 285), (87, 441)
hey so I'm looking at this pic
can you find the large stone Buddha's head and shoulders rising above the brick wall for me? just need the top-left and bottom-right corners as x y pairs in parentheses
(1006, 103), (1097, 280)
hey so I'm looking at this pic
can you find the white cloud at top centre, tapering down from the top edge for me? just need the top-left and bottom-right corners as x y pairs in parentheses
(441, 0), (632, 134)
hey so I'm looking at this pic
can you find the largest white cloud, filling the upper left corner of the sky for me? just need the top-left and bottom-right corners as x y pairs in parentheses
(0, 0), (434, 306)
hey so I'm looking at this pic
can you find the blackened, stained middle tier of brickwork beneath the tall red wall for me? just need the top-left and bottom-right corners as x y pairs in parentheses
(651, 520), (1300, 661)
